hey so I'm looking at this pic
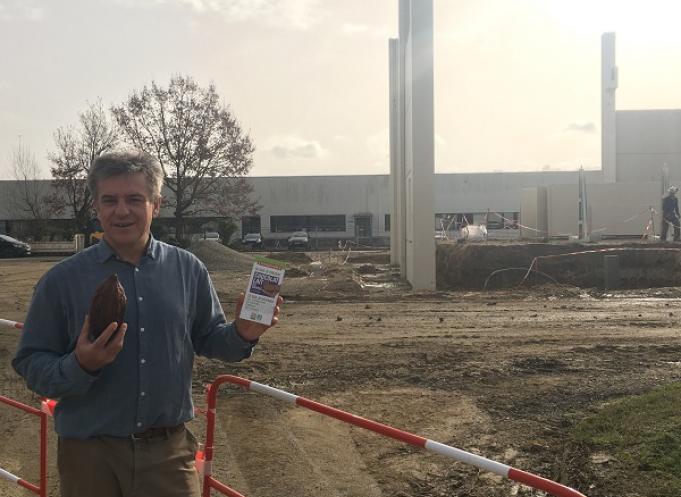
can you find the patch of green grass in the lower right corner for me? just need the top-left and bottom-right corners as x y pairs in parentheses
(575, 383), (681, 497)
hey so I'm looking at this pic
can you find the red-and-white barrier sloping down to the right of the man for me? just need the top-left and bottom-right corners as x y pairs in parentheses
(202, 375), (586, 497)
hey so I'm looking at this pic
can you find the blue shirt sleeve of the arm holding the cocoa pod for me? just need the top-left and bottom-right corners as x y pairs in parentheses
(12, 273), (97, 398)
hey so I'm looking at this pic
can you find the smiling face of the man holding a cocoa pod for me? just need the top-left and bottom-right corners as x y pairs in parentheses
(94, 173), (161, 249)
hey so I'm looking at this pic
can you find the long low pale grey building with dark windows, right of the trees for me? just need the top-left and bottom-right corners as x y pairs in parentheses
(242, 171), (572, 244)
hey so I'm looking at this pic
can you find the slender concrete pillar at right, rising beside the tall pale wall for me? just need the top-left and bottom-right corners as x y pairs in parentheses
(601, 33), (618, 183)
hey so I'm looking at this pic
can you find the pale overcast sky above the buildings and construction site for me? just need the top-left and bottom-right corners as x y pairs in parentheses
(0, 0), (681, 179)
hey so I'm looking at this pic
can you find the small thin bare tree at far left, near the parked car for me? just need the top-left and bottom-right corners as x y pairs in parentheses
(8, 145), (58, 239)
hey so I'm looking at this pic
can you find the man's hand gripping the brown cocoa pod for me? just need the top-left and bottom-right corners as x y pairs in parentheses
(74, 316), (128, 373)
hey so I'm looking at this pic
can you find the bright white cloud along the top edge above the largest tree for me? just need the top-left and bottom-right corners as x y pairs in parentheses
(120, 0), (321, 30)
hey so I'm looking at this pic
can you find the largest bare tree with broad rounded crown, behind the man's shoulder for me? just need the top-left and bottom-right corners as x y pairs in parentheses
(112, 76), (258, 240)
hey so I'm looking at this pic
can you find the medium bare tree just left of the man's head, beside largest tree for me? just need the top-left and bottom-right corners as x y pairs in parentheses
(48, 100), (120, 230)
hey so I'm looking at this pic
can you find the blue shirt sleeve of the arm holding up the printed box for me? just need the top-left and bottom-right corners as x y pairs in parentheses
(192, 264), (255, 362)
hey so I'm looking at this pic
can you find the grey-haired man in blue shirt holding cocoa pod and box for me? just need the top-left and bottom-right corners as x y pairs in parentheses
(12, 153), (282, 497)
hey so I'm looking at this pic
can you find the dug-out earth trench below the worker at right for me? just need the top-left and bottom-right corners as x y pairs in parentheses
(437, 242), (681, 290)
